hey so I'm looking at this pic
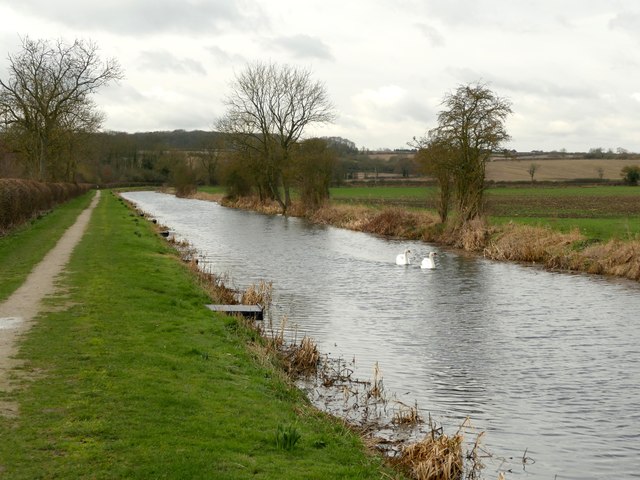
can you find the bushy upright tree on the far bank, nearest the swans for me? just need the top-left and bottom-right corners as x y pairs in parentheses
(429, 83), (511, 222)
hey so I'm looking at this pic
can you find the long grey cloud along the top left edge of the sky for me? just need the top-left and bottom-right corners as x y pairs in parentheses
(1, 0), (260, 35)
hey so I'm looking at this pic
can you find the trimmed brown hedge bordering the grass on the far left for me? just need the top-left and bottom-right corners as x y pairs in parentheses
(0, 178), (89, 235)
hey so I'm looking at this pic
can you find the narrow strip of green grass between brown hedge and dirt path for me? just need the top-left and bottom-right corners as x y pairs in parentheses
(0, 192), (95, 301)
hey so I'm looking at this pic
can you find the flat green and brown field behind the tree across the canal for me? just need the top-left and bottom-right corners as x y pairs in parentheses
(331, 186), (640, 240)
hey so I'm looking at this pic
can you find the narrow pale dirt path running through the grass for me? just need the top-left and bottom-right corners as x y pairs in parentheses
(0, 191), (100, 417)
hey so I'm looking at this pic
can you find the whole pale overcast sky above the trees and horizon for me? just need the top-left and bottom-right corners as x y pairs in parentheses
(0, 0), (640, 152)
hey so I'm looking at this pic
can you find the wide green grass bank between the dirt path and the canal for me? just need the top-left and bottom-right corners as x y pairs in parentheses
(0, 189), (397, 479)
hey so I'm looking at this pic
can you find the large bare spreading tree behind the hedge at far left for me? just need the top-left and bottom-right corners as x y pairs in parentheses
(0, 37), (123, 180)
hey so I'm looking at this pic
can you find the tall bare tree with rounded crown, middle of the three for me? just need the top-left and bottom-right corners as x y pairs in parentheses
(217, 62), (335, 213)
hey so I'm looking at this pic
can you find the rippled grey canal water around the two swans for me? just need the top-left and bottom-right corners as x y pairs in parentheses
(123, 192), (640, 480)
